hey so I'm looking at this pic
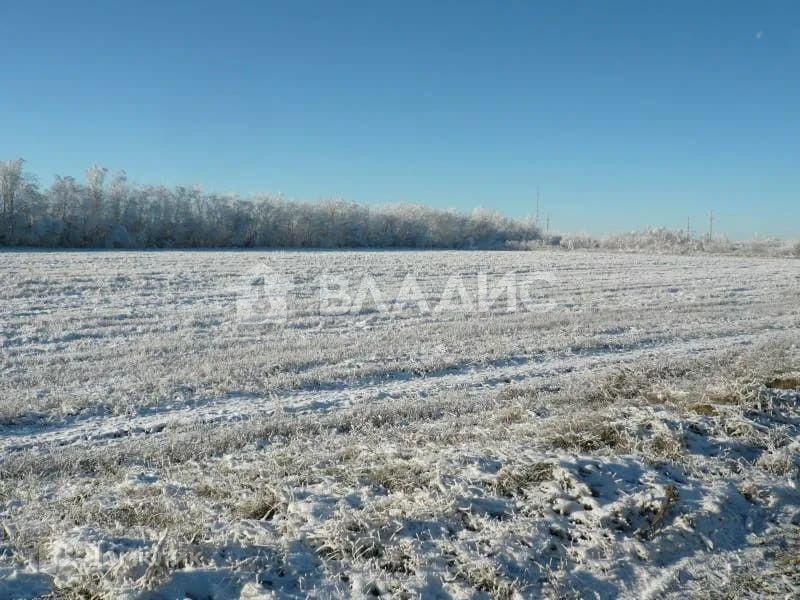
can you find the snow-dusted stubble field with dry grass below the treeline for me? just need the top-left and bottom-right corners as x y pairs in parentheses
(0, 251), (800, 599)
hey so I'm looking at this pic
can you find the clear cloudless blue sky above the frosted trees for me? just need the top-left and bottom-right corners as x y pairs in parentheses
(0, 0), (800, 237)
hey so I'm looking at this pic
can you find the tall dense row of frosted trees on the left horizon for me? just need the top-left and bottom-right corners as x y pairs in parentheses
(0, 160), (541, 248)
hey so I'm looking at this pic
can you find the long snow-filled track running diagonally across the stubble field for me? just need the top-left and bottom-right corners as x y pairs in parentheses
(0, 334), (757, 453)
